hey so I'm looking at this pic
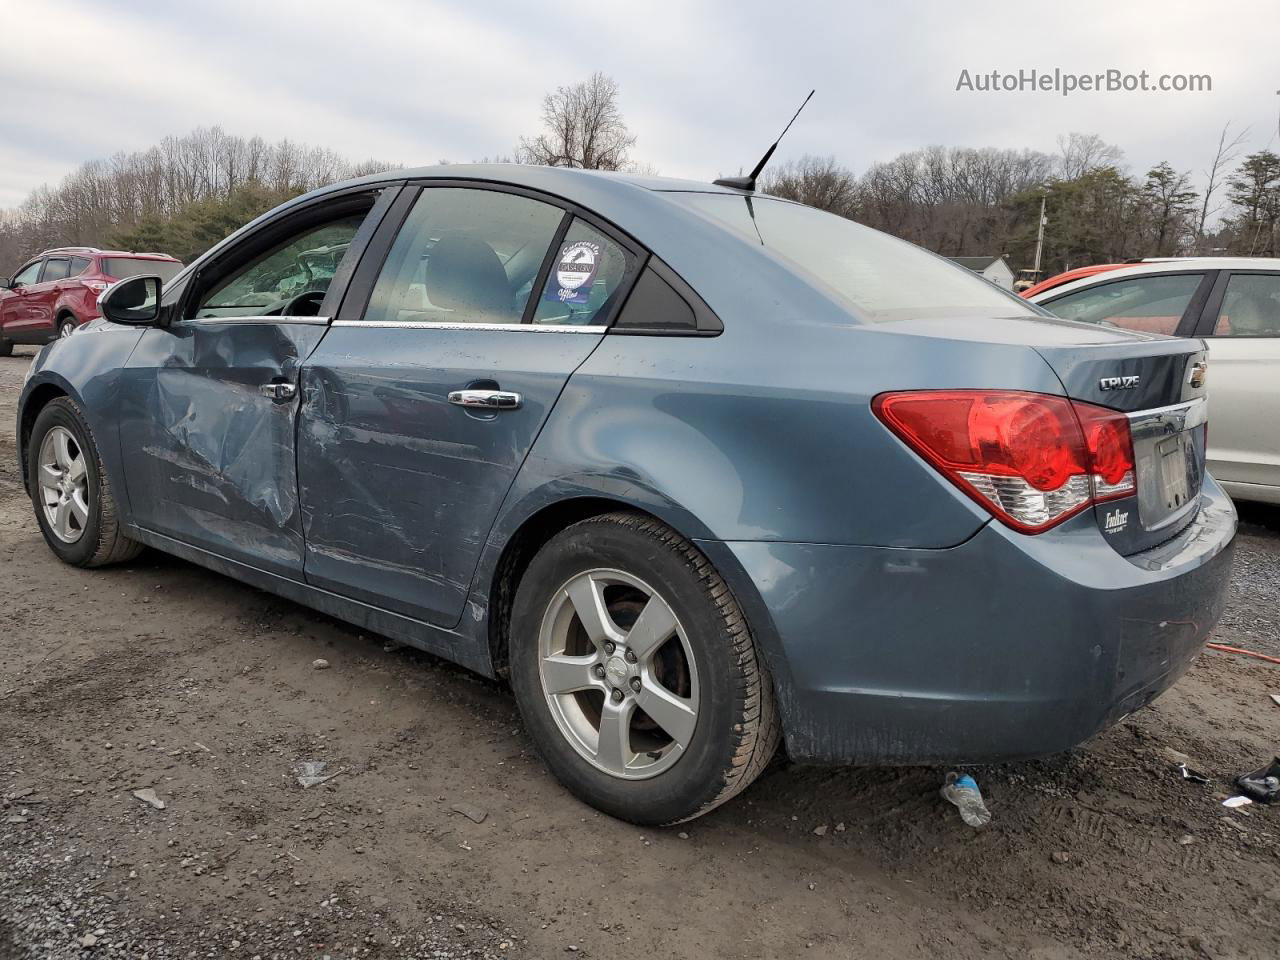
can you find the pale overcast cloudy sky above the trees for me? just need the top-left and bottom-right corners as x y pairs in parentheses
(0, 0), (1280, 207)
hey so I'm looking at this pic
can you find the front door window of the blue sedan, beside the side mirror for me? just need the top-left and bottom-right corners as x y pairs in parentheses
(194, 212), (366, 317)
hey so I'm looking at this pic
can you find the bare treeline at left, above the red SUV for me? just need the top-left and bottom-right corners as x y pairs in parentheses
(0, 127), (389, 271)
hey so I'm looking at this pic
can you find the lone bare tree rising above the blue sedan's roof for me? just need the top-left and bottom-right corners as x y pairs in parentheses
(516, 73), (636, 170)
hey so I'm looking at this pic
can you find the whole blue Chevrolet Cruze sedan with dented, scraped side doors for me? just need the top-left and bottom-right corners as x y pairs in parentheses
(18, 165), (1235, 823)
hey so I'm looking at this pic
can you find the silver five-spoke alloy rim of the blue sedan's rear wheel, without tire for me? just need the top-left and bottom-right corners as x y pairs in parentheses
(538, 570), (699, 780)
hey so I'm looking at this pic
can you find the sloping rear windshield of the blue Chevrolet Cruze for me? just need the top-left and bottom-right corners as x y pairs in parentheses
(668, 193), (1041, 320)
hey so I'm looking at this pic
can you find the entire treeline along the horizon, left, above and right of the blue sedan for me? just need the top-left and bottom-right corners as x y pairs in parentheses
(0, 110), (1280, 274)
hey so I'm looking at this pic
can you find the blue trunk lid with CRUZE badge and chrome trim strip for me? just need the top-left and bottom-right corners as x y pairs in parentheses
(886, 317), (1207, 556)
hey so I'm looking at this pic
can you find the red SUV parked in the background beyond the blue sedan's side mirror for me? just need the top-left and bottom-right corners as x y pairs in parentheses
(0, 247), (182, 357)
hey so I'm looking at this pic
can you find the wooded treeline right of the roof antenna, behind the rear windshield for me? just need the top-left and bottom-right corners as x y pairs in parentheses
(763, 131), (1280, 274)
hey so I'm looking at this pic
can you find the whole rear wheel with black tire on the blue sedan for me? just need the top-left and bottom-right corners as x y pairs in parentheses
(511, 513), (780, 826)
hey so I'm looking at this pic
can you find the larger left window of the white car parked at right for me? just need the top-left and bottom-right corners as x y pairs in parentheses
(1044, 274), (1203, 334)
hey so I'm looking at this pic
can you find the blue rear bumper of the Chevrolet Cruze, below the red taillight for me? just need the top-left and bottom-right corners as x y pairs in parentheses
(713, 477), (1236, 763)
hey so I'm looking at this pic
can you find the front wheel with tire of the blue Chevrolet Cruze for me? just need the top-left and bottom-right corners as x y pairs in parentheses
(27, 397), (142, 567)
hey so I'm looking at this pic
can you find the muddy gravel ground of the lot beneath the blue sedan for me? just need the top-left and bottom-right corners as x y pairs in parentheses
(0, 348), (1280, 960)
